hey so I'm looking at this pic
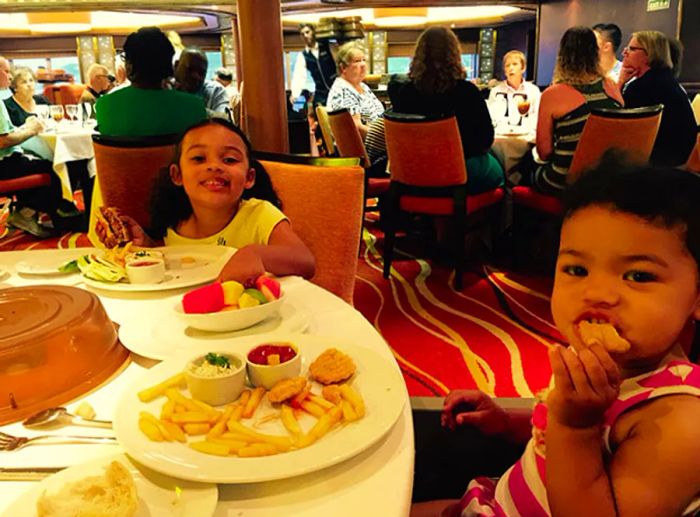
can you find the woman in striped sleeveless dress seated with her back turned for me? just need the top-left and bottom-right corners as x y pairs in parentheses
(522, 27), (623, 194)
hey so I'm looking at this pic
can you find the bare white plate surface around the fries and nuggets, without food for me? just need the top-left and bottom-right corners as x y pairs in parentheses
(114, 334), (408, 483)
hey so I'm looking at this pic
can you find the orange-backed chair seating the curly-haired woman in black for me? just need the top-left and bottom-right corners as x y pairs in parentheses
(384, 112), (504, 290)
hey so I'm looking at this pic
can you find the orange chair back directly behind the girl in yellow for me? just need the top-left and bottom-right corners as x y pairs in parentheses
(260, 154), (363, 305)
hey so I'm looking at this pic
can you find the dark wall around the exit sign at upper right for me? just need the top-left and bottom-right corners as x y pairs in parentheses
(535, 0), (680, 86)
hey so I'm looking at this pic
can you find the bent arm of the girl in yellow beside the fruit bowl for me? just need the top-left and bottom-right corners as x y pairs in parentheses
(218, 221), (316, 284)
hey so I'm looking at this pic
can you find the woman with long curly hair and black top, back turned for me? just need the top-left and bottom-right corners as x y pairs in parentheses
(388, 27), (503, 193)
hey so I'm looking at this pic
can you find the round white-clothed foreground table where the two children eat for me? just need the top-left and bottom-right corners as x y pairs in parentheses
(0, 248), (414, 517)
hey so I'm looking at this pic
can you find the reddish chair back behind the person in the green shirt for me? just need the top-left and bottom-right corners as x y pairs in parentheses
(90, 134), (177, 230)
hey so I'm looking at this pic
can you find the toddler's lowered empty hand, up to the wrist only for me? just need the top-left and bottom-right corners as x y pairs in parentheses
(440, 390), (509, 436)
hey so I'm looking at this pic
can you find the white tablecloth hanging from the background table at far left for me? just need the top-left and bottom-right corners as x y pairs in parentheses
(38, 127), (95, 201)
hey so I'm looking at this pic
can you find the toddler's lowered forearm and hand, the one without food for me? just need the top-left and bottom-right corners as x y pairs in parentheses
(440, 390), (532, 444)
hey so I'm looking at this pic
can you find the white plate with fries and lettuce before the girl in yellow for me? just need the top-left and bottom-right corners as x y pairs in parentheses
(81, 243), (236, 292)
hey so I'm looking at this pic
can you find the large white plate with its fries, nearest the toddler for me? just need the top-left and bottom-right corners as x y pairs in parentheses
(114, 334), (408, 483)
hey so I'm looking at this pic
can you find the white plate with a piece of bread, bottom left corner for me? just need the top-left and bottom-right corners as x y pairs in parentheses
(5, 454), (219, 517)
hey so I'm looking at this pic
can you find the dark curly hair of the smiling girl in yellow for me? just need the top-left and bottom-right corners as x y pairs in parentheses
(148, 117), (282, 239)
